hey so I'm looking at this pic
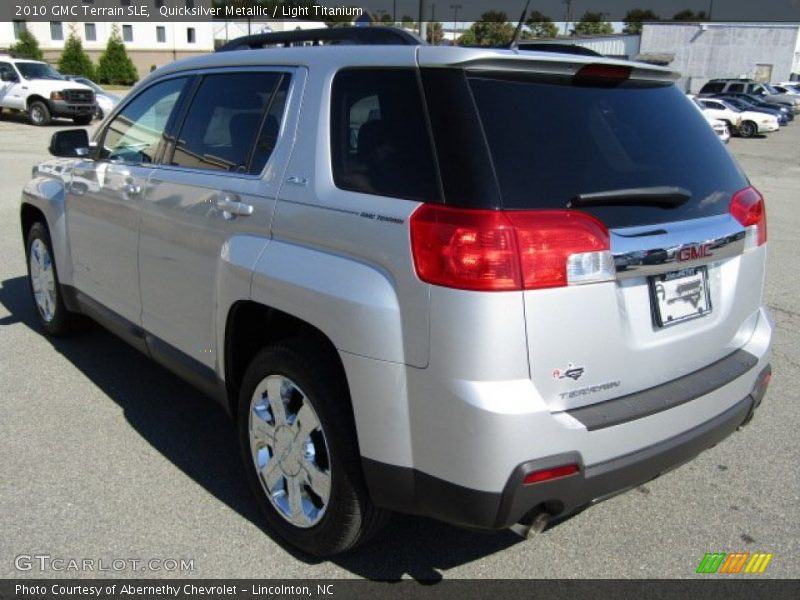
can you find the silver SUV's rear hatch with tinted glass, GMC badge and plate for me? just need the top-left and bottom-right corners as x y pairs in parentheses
(422, 52), (765, 411)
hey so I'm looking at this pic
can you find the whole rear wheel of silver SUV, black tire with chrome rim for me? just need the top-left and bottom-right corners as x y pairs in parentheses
(238, 339), (387, 556)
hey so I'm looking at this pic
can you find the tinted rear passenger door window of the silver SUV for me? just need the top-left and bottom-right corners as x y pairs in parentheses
(170, 72), (290, 174)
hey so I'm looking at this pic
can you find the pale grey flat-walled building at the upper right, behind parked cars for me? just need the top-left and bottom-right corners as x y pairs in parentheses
(639, 22), (800, 92)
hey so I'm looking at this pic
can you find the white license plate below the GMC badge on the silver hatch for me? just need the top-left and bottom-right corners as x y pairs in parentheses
(650, 267), (711, 327)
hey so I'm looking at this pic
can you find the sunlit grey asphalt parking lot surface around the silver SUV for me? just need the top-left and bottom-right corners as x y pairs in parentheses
(0, 118), (800, 579)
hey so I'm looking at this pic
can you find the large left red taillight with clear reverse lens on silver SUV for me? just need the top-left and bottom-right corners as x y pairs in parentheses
(411, 204), (614, 291)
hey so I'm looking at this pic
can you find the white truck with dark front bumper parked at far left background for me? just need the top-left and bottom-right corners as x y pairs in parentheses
(0, 55), (97, 125)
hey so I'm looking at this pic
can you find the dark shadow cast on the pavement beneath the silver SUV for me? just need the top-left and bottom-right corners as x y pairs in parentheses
(0, 277), (521, 583)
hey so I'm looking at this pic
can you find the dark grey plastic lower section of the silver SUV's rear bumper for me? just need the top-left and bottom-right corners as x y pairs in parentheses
(362, 366), (770, 529)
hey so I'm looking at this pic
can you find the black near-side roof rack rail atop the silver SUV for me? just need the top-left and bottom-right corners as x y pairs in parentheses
(217, 27), (423, 52)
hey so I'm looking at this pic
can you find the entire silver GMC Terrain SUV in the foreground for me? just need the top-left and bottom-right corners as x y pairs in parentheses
(21, 28), (773, 555)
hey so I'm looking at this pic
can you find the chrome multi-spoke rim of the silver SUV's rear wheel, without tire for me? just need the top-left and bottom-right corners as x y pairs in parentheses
(249, 375), (331, 529)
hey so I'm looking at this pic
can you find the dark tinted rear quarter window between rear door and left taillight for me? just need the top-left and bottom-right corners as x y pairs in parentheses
(331, 69), (439, 201)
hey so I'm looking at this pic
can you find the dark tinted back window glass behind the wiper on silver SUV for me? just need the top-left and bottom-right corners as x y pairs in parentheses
(467, 74), (747, 227)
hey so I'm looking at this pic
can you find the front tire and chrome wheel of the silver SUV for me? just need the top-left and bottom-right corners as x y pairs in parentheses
(25, 222), (81, 336)
